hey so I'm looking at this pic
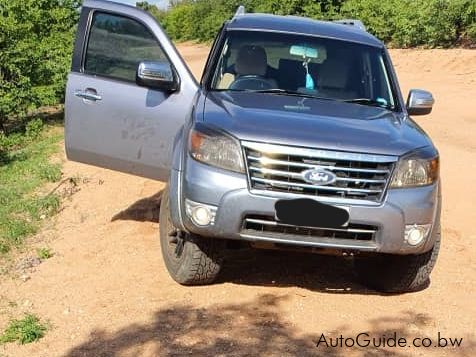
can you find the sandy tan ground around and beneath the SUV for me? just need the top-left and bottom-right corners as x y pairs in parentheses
(0, 45), (476, 356)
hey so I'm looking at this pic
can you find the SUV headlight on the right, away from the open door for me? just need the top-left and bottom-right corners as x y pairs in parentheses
(390, 149), (440, 188)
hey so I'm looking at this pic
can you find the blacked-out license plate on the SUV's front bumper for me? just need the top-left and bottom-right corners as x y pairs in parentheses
(274, 198), (349, 228)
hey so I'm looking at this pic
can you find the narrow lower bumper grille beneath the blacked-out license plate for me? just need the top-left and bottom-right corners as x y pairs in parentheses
(243, 216), (378, 241)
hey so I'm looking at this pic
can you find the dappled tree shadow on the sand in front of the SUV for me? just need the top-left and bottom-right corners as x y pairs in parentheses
(67, 294), (476, 357)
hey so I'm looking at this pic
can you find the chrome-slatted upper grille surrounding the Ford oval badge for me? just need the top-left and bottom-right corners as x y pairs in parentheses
(242, 142), (397, 202)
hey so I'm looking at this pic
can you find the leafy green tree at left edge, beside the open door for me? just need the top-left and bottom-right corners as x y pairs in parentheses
(0, 0), (80, 131)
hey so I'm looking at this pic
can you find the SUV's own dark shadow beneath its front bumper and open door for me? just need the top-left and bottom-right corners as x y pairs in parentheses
(111, 191), (424, 295)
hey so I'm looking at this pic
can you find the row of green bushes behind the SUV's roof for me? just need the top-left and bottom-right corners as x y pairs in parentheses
(160, 0), (476, 47)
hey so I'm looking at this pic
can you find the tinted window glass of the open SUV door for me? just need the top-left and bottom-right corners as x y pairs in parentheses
(84, 13), (167, 81)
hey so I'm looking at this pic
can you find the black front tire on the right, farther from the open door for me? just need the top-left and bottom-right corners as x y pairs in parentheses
(354, 225), (441, 293)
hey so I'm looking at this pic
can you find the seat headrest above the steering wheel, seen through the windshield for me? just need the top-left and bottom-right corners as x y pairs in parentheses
(235, 45), (268, 76)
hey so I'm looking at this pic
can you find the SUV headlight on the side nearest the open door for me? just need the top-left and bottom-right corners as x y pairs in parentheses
(189, 124), (245, 173)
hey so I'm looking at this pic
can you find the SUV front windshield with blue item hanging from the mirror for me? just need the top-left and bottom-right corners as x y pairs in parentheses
(211, 31), (395, 109)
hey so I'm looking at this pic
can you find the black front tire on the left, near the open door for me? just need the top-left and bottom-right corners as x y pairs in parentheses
(159, 186), (224, 285)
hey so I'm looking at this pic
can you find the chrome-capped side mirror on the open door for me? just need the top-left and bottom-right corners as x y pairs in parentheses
(136, 61), (180, 92)
